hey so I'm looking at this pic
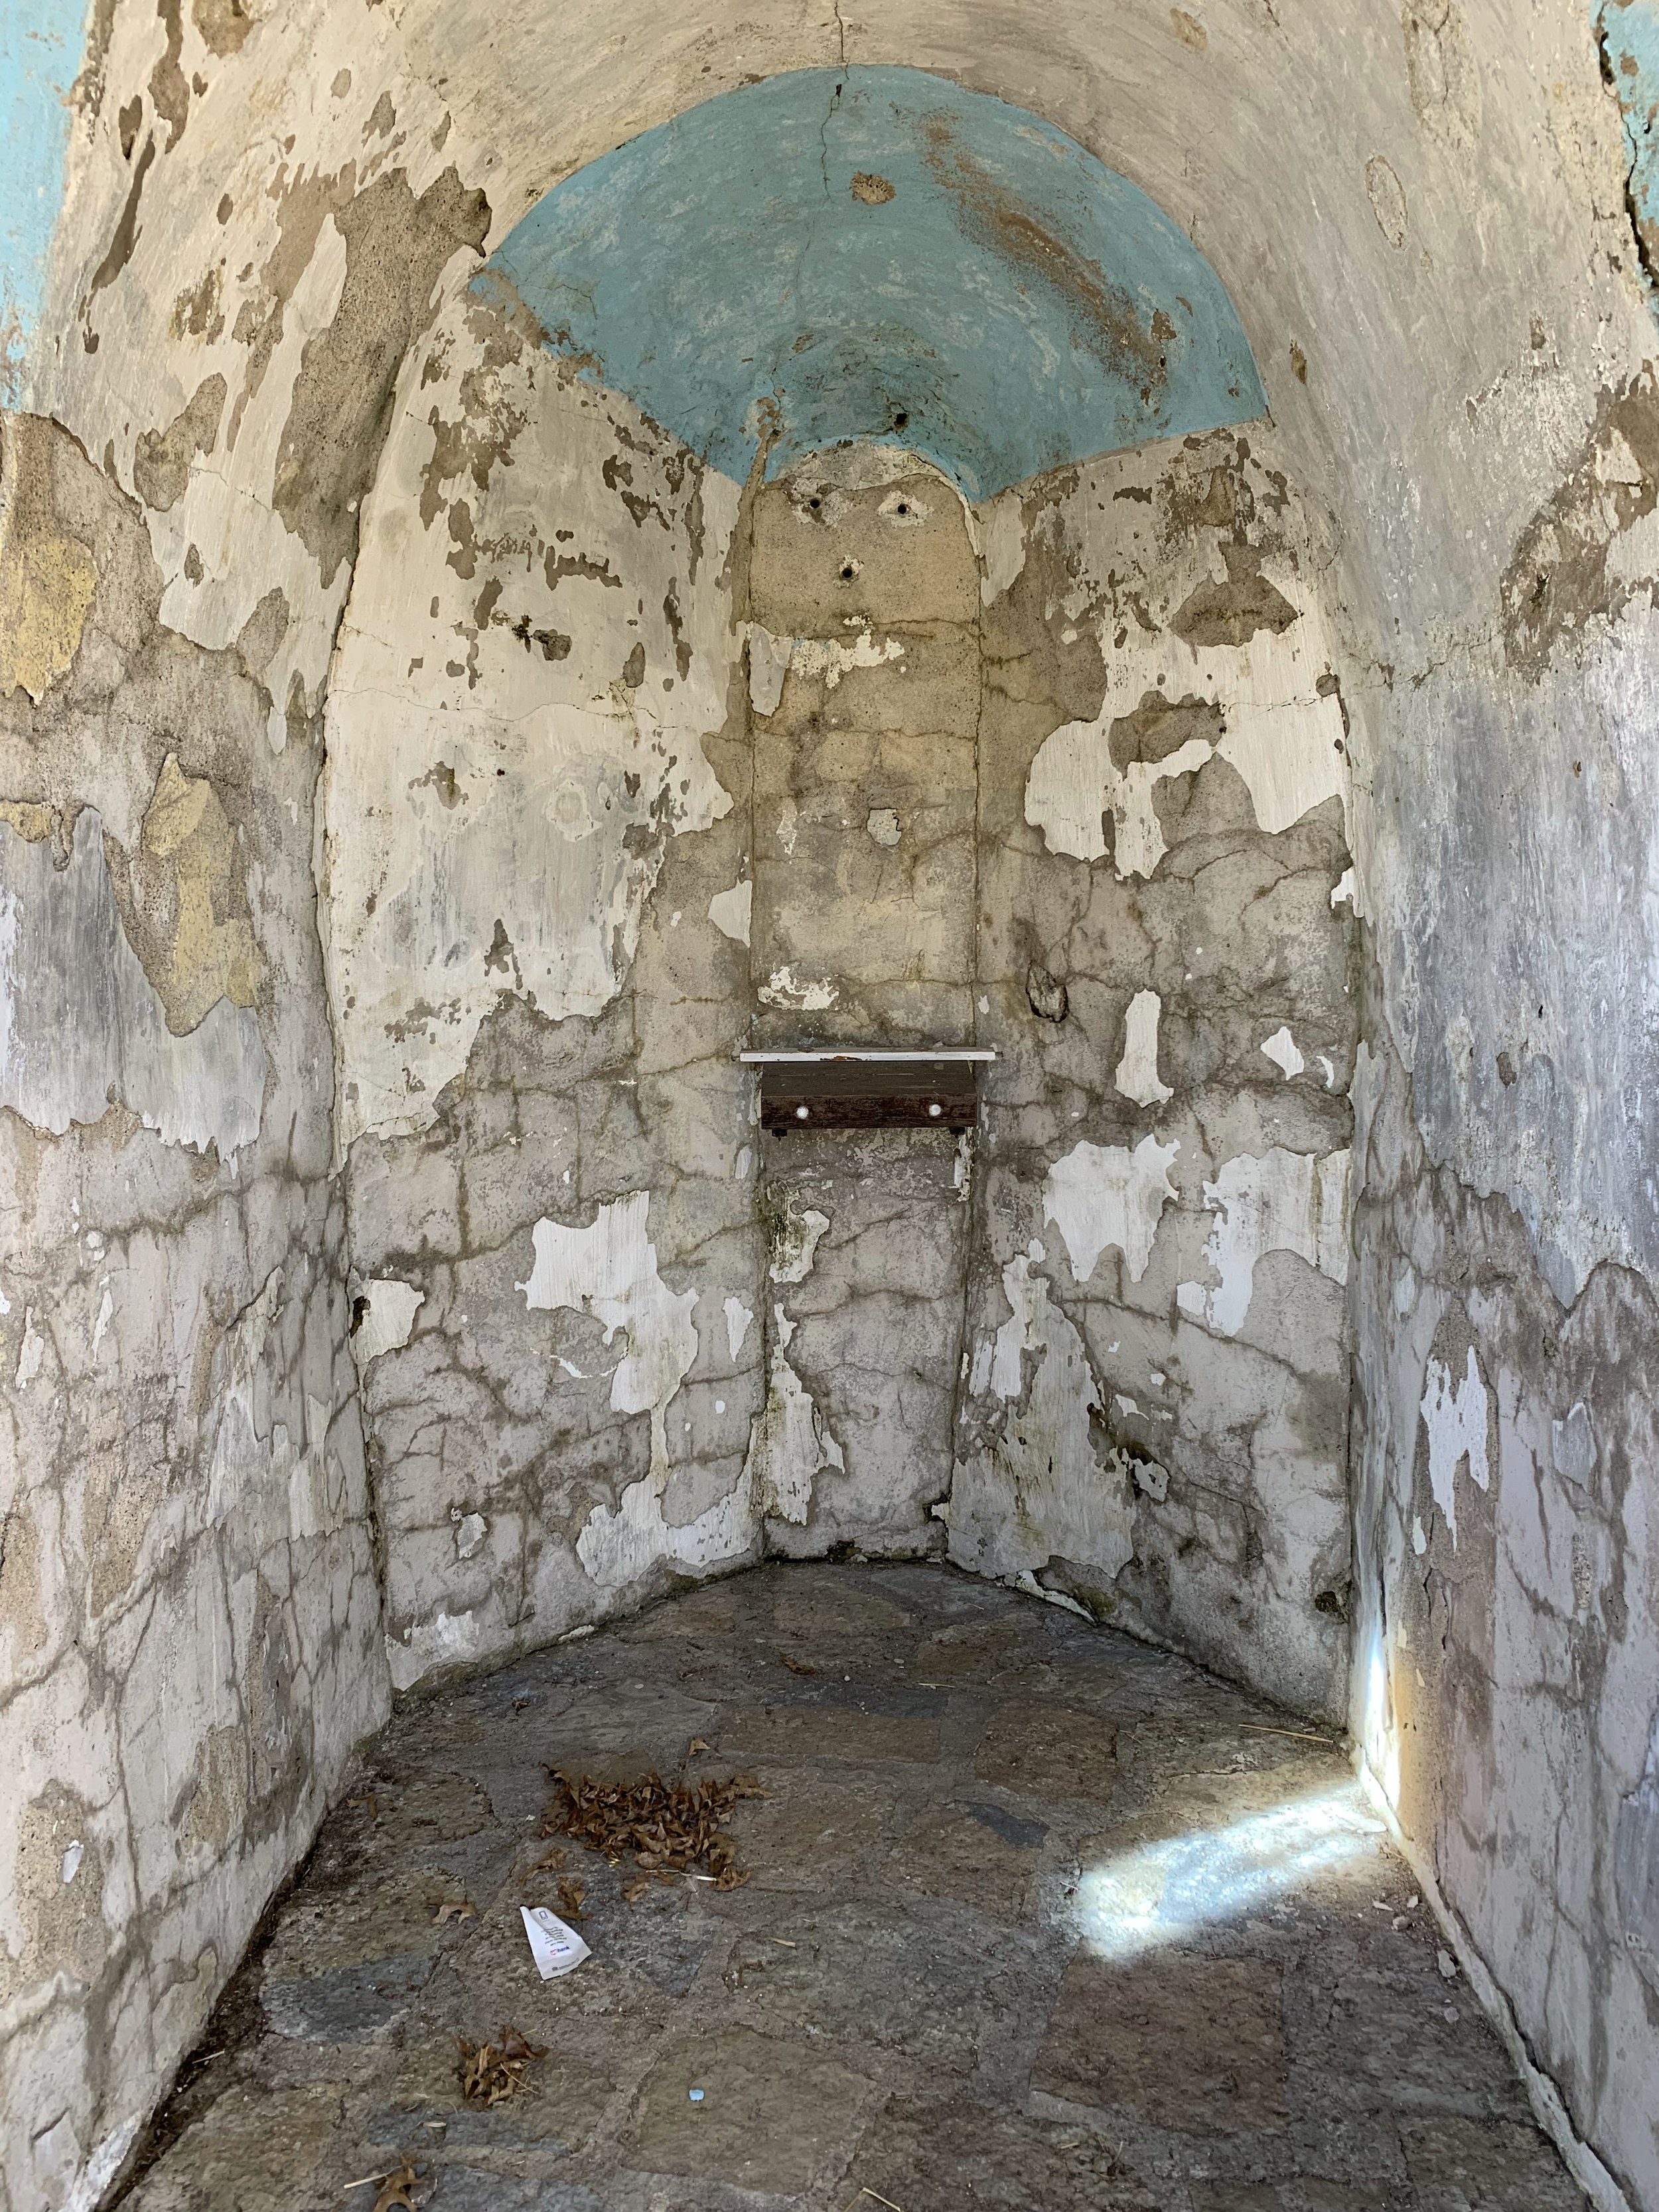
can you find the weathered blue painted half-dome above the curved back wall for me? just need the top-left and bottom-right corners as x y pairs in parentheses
(486, 68), (1267, 498)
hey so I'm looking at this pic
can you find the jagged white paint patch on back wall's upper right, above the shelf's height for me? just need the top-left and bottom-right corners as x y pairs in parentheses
(1027, 573), (1347, 876)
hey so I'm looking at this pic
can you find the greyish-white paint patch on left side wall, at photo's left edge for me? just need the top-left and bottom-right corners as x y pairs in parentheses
(0, 808), (265, 1159)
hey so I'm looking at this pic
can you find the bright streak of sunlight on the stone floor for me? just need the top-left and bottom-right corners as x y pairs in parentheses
(1075, 1783), (1382, 1960)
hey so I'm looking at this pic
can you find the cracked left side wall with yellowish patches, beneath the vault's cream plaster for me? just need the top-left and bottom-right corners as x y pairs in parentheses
(0, 413), (385, 2212)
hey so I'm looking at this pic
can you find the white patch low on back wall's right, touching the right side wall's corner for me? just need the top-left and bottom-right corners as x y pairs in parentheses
(1175, 1143), (1354, 1336)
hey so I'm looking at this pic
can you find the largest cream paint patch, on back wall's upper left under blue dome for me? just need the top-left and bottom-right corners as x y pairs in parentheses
(321, 309), (737, 1157)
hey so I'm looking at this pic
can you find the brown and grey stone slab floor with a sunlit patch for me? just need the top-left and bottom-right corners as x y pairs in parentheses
(126, 1566), (1581, 2212)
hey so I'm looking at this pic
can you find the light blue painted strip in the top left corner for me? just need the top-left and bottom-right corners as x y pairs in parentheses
(0, 0), (86, 387)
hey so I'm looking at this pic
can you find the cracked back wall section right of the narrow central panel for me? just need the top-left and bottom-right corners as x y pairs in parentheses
(940, 431), (1358, 1714)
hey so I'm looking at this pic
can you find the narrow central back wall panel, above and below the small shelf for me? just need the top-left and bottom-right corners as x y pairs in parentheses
(748, 445), (982, 1557)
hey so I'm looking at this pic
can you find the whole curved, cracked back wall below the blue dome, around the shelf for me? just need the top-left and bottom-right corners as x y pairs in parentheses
(338, 407), (1356, 1712)
